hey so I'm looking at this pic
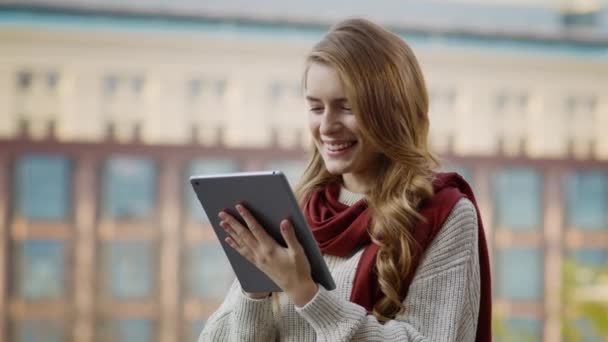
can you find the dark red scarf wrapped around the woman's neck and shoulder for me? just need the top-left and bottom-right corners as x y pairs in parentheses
(304, 173), (492, 342)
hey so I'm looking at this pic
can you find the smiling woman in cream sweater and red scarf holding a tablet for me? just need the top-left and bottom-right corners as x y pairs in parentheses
(200, 19), (491, 342)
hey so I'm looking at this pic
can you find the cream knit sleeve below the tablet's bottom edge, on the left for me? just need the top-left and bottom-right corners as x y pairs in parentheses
(198, 280), (276, 342)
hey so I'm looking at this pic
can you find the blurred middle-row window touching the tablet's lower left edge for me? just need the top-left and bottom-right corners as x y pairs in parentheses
(186, 241), (235, 301)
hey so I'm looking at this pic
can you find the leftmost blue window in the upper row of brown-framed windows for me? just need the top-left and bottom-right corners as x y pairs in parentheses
(15, 155), (71, 220)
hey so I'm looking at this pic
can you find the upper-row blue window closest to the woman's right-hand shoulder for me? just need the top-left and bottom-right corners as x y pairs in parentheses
(494, 169), (543, 230)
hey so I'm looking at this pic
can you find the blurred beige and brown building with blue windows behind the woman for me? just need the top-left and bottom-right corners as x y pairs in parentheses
(0, 0), (608, 342)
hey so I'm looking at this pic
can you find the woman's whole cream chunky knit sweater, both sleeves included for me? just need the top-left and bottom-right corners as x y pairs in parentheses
(199, 188), (480, 342)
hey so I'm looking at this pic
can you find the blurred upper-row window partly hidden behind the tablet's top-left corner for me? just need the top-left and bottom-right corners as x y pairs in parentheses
(186, 159), (239, 223)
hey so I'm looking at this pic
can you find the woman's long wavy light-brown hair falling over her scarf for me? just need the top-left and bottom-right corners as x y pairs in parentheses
(295, 19), (438, 322)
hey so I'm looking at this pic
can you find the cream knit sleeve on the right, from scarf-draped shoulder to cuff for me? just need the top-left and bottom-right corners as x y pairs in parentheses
(296, 199), (480, 342)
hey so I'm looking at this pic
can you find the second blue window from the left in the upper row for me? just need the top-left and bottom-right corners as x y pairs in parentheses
(103, 158), (157, 219)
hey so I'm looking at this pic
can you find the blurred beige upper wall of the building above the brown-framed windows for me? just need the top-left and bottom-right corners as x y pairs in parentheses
(0, 29), (608, 159)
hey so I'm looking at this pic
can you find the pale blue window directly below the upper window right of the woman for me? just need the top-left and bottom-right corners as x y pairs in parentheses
(496, 248), (544, 300)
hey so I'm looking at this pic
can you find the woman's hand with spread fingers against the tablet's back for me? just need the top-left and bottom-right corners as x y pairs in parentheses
(218, 204), (318, 307)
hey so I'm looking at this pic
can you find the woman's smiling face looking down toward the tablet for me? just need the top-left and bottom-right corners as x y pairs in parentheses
(306, 62), (378, 190)
